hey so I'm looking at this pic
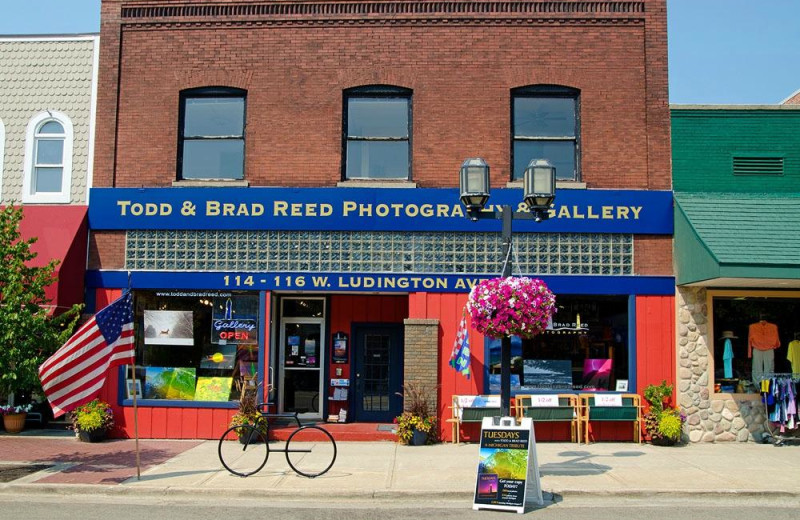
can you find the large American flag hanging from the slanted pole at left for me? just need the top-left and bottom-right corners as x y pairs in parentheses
(39, 292), (136, 417)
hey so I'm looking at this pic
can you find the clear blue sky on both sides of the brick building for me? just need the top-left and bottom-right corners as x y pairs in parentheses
(0, 0), (800, 104)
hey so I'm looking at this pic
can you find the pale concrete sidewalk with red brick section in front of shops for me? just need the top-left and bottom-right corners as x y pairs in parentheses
(0, 434), (800, 499)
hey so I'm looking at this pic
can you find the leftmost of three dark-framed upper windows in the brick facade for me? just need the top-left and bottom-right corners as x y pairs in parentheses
(178, 87), (246, 180)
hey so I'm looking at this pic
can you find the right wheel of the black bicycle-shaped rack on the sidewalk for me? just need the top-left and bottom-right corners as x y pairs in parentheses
(286, 426), (336, 478)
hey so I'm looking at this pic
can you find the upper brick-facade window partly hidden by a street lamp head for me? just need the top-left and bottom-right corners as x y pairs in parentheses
(511, 85), (581, 181)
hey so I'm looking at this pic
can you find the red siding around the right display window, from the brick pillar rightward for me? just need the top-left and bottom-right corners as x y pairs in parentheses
(409, 293), (676, 441)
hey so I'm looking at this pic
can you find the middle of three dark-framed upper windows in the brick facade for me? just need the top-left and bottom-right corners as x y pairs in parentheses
(344, 86), (411, 180)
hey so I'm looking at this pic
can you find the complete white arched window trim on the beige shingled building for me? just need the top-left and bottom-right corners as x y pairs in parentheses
(22, 110), (74, 204)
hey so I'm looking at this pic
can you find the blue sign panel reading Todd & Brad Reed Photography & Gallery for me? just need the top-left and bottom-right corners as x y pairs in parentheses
(89, 187), (673, 234)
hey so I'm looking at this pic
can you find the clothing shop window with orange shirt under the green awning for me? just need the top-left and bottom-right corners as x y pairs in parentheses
(710, 296), (800, 394)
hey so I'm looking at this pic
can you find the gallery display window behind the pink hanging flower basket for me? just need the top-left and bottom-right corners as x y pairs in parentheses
(485, 295), (628, 395)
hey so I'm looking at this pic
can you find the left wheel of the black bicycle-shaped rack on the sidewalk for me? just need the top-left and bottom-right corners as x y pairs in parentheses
(217, 424), (269, 477)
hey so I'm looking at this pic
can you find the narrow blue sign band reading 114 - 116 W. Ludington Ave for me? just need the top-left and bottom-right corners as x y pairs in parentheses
(86, 271), (675, 296)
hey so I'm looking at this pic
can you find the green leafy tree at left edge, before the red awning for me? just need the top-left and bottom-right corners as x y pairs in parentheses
(0, 206), (82, 395)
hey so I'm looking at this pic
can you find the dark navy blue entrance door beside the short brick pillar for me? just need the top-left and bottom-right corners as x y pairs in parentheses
(353, 324), (403, 422)
